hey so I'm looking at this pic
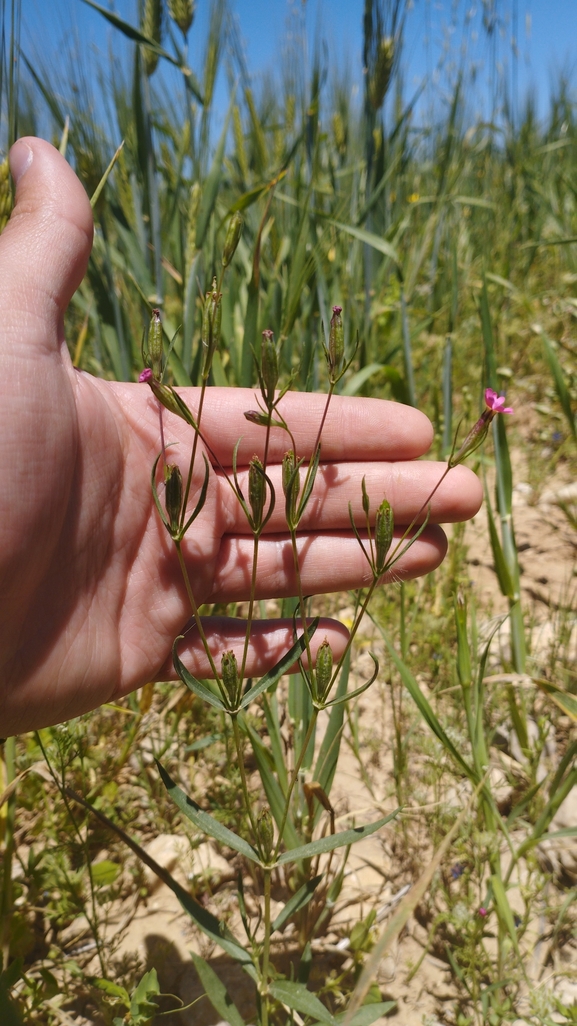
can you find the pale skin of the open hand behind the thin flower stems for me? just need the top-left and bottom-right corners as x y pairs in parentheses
(0, 139), (482, 737)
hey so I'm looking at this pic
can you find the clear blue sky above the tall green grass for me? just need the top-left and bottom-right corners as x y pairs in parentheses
(22, 0), (577, 132)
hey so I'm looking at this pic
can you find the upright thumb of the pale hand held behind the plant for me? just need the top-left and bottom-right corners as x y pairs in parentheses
(0, 137), (92, 350)
